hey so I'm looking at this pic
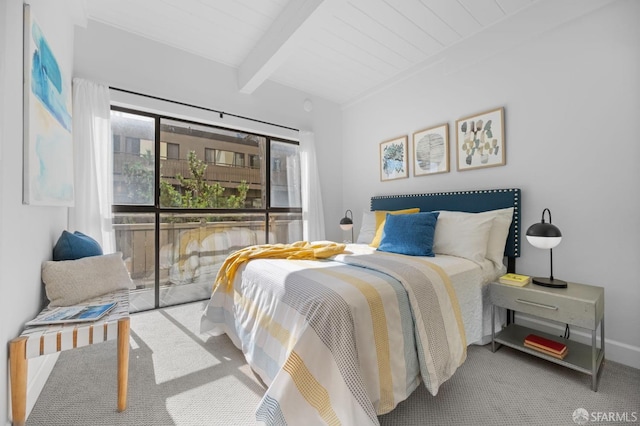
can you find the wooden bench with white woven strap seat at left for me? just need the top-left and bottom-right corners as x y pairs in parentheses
(9, 289), (129, 426)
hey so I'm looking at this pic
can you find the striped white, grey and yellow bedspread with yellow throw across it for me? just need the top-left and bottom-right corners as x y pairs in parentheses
(200, 243), (466, 426)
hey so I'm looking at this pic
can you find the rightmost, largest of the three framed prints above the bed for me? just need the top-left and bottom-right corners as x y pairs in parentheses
(456, 107), (506, 171)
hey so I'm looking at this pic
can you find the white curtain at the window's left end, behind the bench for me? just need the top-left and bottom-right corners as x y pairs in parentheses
(69, 78), (115, 254)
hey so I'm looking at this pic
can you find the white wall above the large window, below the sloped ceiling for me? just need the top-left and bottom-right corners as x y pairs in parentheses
(74, 21), (342, 245)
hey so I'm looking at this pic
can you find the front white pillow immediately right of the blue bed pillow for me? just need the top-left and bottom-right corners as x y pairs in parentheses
(433, 210), (494, 264)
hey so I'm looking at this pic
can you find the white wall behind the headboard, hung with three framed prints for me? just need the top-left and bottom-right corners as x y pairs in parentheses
(343, 0), (640, 368)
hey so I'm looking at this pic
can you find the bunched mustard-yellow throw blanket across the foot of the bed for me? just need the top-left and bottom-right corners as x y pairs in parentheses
(213, 241), (346, 293)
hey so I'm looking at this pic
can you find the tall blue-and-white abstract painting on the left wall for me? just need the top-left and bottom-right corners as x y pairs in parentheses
(23, 4), (74, 206)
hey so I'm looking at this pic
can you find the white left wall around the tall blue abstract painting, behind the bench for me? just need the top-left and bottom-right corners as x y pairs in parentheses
(0, 0), (80, 424)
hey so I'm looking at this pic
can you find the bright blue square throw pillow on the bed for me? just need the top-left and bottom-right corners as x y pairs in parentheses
(378, 212), (440, 257)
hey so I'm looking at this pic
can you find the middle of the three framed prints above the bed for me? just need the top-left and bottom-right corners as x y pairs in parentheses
(413, 124), (449, 176)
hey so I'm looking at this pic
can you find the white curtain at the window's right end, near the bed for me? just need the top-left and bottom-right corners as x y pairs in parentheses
(300, 131), (325, 241)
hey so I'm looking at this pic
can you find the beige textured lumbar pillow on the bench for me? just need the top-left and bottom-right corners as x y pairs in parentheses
(42, 253), (133, 306)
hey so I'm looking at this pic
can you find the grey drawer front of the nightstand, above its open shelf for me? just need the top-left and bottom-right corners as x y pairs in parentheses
(491, 284), (603, 330)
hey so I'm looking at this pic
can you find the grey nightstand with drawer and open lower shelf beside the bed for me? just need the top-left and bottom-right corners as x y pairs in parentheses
(489, 282), (604, 392)
